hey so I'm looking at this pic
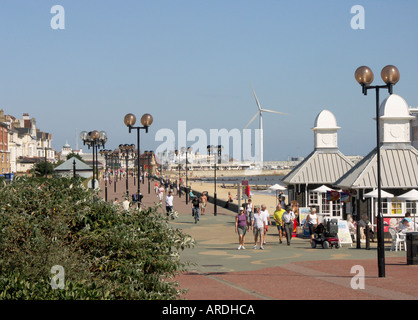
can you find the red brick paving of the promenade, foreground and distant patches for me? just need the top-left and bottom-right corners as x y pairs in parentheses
(98, 179), (418, 300)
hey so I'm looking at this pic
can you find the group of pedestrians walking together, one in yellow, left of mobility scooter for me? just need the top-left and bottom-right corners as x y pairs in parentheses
(235, 199), (296, 250)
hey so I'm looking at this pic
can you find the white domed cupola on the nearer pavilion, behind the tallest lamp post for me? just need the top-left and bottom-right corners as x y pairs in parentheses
(379, 94), (415, 144)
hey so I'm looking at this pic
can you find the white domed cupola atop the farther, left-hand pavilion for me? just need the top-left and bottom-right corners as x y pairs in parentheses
(312, 110), (340, 149)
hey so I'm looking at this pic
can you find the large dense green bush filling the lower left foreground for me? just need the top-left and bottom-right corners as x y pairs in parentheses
(0, 177), (194, 300)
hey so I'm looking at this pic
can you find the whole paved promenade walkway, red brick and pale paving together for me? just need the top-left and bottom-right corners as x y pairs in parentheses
(99, 179), (418, 300)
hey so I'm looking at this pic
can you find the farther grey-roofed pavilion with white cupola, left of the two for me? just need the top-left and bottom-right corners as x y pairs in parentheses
(282, 110), (354, 219)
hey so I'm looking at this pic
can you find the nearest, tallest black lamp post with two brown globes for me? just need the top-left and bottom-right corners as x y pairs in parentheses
(354, 65), (400, 278)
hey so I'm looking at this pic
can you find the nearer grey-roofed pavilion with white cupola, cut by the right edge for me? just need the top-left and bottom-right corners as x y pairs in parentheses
(334, 94), (418, 232)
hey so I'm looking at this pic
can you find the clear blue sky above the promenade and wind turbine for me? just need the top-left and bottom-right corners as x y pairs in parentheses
(0, 0), (418, 161)
